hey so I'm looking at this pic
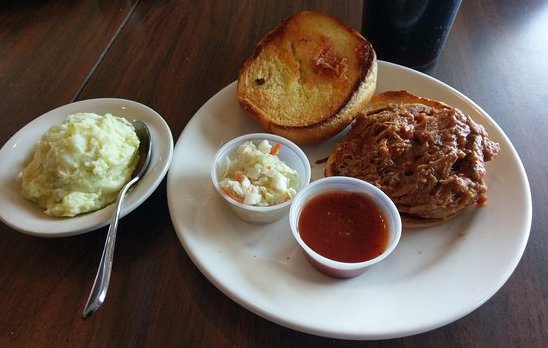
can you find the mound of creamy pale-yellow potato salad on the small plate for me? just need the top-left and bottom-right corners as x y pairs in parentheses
(21, 113), (139, 217)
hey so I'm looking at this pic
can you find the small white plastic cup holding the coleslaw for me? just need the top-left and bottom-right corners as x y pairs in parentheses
(211, 133), (311, 224)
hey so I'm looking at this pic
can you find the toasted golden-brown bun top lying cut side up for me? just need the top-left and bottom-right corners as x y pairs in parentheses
(237, 11), (376, 142)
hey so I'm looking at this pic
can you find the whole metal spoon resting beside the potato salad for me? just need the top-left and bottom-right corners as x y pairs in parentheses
(82, 120), (152, 319)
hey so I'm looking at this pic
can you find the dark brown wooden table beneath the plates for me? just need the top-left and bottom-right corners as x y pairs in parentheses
(0, 0), (548, 347)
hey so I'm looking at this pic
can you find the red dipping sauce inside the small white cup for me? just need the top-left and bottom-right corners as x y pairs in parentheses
(298, 191), (389, 262)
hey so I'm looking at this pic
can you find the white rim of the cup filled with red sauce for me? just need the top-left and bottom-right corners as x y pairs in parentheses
(289, 176), (402, 271)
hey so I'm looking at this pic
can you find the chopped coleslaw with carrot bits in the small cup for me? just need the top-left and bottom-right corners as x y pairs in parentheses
(219, 140), (299, 206)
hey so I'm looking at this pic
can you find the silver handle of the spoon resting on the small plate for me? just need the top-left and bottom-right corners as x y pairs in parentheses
(82, 176), (139, 319)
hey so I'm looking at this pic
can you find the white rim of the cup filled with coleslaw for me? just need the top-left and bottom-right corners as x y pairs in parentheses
(210, 133), (312, 212)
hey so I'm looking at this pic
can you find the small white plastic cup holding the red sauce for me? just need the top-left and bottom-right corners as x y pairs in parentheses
(289, 176), (402, 278)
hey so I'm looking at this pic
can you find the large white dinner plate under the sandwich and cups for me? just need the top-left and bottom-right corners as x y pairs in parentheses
(167, 62), (532, 339)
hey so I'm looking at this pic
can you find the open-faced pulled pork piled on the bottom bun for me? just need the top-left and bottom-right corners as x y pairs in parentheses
(325, 91), (500, 227)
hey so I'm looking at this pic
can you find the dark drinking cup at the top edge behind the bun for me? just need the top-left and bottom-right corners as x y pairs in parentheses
(362, 0), (462, 70)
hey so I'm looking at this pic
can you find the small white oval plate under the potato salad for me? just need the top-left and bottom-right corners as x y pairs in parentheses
(0, 98), (173, 237)
